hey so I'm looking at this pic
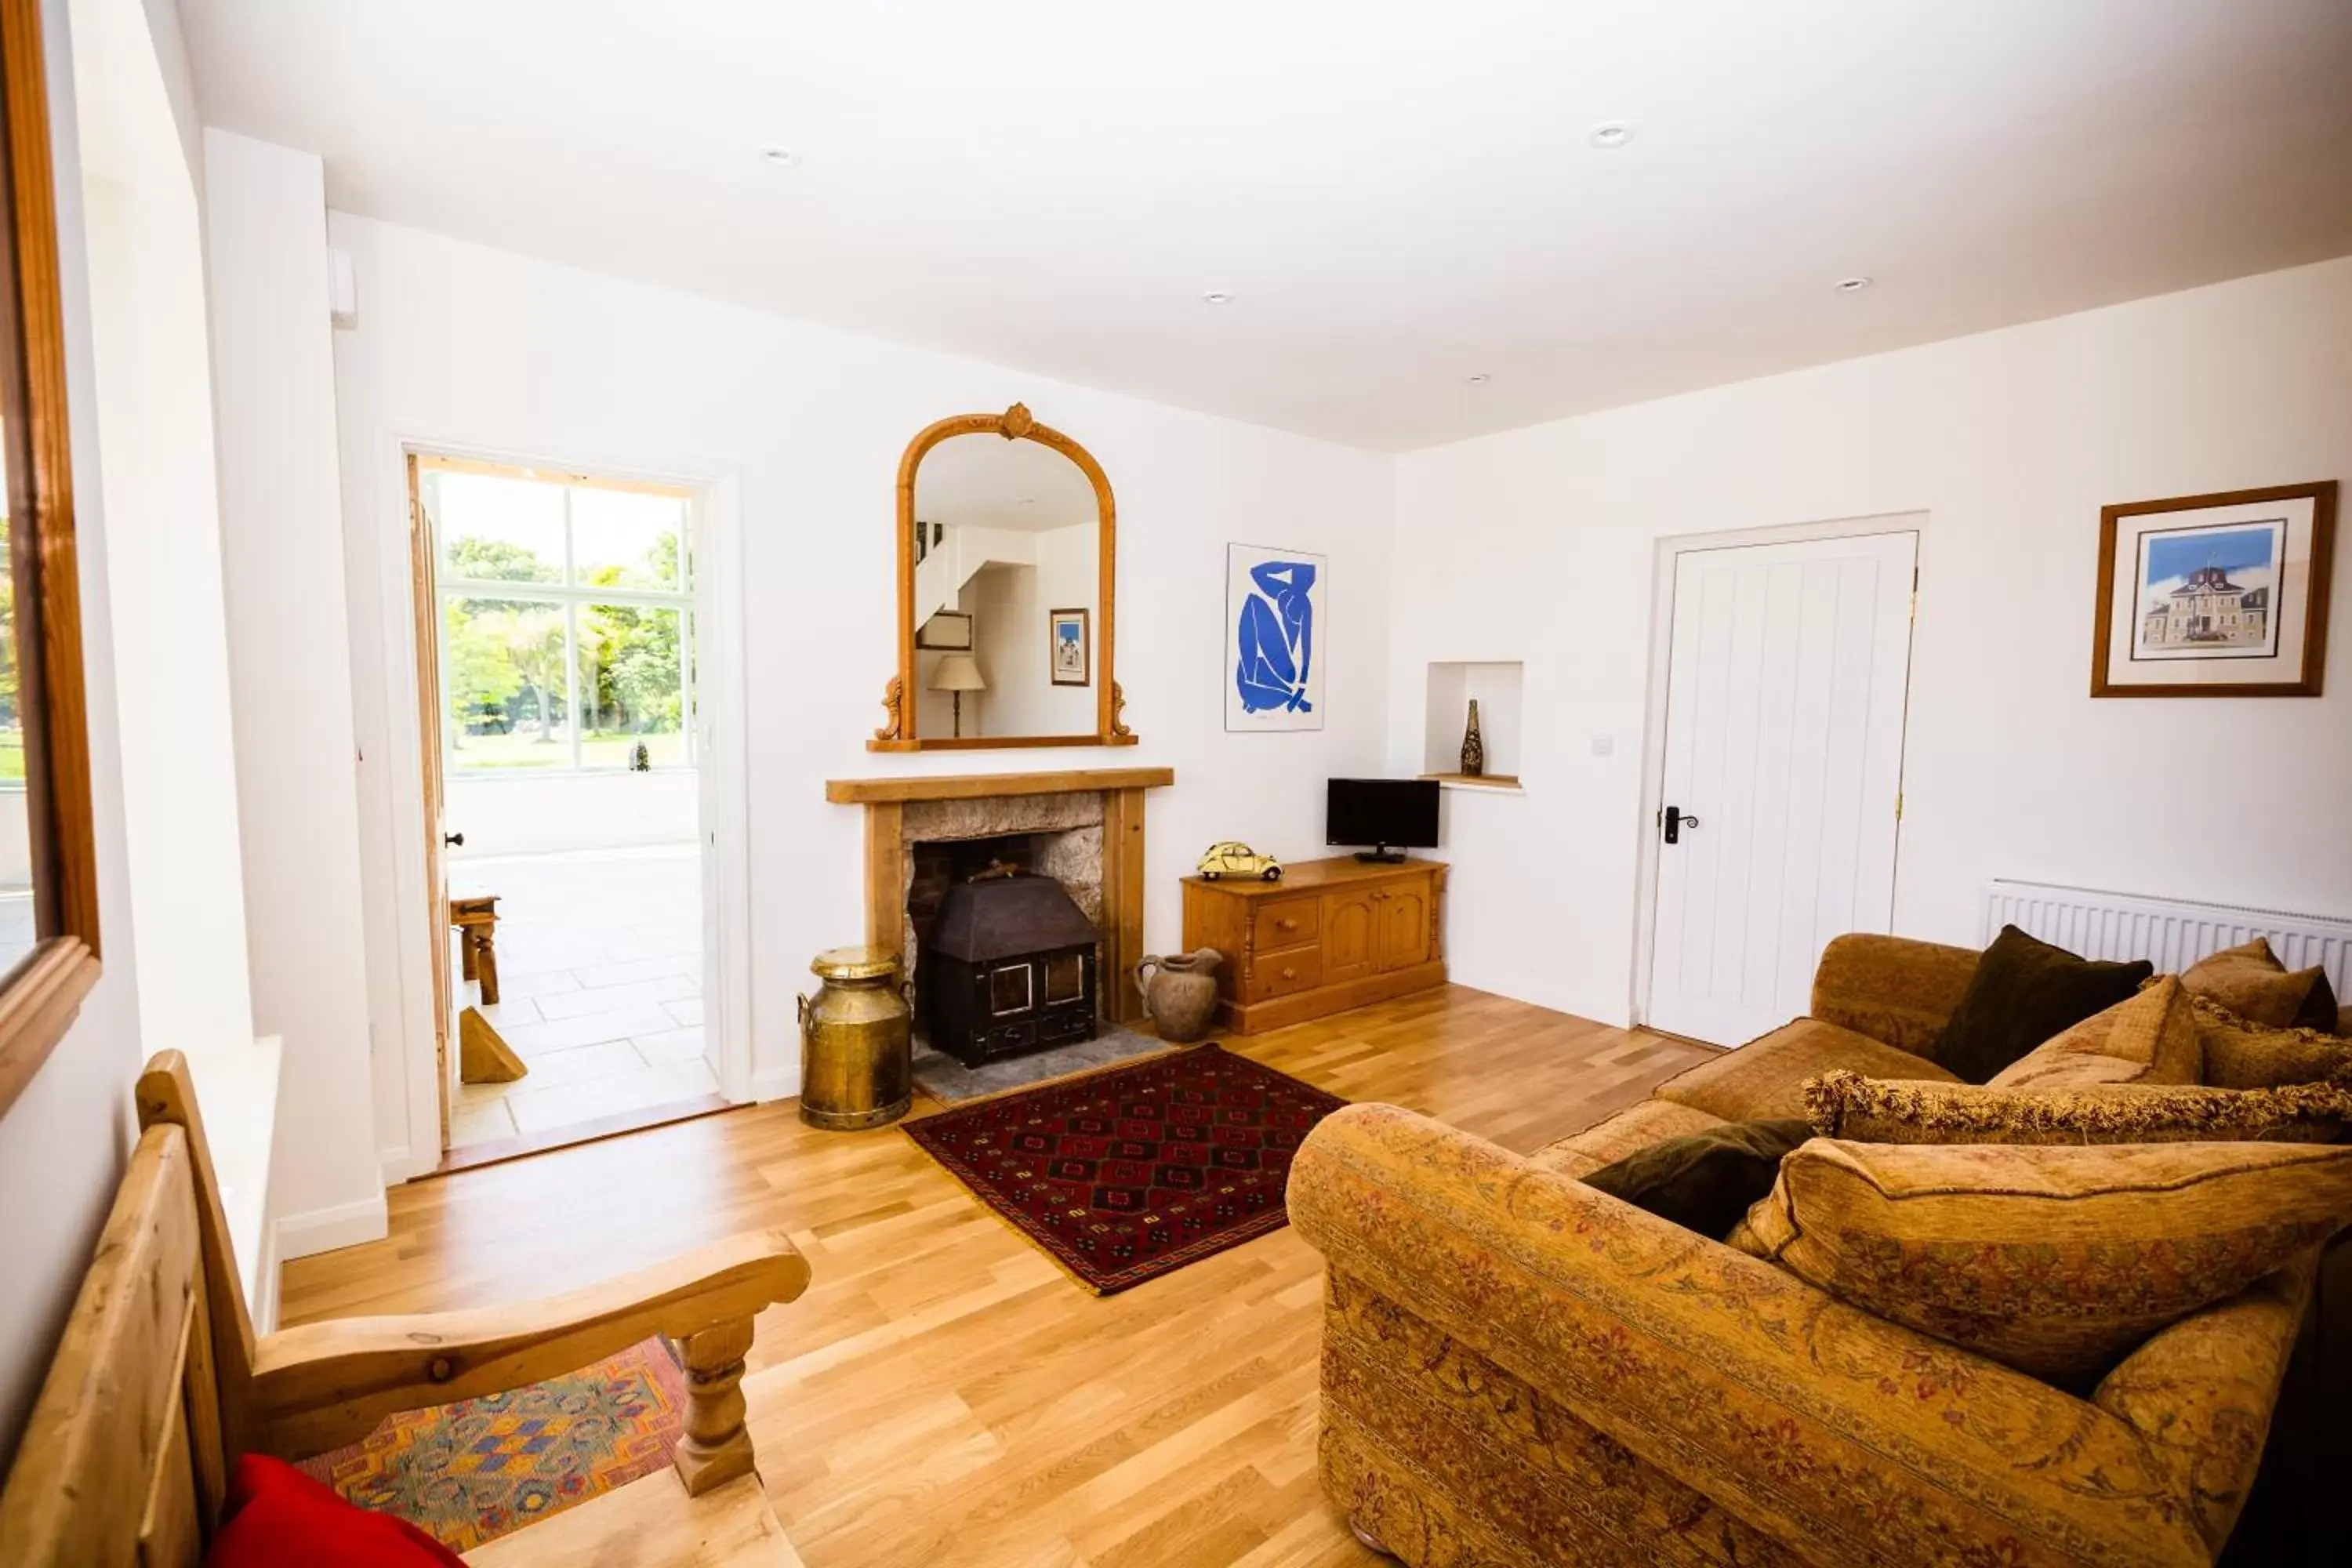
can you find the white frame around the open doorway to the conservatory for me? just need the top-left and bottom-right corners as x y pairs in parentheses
(383, 435), (748, 1182)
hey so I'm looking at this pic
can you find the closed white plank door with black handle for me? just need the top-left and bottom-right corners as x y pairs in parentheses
(1646, 534), (1919, 1046)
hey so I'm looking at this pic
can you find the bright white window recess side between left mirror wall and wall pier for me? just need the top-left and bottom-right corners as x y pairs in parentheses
(73, 0), (266, 1091)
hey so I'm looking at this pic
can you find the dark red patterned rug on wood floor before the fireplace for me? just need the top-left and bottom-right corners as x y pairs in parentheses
(906, 1046), (1345, 1295)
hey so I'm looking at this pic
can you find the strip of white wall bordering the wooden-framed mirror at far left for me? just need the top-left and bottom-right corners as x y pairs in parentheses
(0, 0), (141, 1467)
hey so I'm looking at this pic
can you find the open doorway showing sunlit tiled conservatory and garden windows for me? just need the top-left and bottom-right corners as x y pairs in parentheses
(407, 452), (727, 1168)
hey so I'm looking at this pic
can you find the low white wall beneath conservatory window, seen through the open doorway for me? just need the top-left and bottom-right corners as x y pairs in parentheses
(445, 769), (699, 860)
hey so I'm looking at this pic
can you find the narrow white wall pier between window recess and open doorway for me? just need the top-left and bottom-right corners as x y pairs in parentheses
(205, 129), (386, 1258)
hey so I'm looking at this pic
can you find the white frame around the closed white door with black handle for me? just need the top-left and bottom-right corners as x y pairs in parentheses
(1625, 508), (1933, 1027)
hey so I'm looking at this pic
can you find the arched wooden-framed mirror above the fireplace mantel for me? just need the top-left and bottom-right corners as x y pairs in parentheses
(884, 402), (1136, 753)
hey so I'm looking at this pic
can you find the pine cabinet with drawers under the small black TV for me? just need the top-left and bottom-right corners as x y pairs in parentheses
(1183, 855), (1446, 1034)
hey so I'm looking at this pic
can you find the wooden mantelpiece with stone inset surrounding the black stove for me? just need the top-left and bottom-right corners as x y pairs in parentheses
(826, 769), (1176, 1022)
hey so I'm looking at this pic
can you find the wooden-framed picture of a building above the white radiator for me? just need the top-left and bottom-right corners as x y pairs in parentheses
(2091, 480), (2336, 696)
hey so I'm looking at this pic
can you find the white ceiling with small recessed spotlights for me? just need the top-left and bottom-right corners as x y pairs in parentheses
(181, 0), (2352, 447)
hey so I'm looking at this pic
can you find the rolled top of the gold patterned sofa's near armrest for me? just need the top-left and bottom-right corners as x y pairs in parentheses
(1289, 1105), (2211, 1568)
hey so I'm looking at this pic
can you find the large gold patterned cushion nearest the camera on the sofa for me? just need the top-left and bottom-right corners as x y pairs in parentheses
(1731, 1138), (2352, 1387)
